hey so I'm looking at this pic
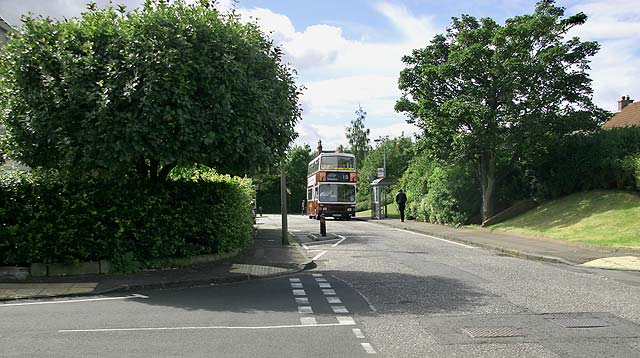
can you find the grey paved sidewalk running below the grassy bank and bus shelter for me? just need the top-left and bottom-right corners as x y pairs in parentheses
(368, 219), (640, 271)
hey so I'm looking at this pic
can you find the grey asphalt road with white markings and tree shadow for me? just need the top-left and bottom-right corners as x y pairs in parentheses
(0, 216), (640, 357)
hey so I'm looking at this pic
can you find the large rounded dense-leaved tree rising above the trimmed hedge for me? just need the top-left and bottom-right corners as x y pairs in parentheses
(0, 0), (300, 183)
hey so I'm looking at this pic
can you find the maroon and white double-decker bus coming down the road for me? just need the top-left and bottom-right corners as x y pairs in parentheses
(306, 152), (357, 220)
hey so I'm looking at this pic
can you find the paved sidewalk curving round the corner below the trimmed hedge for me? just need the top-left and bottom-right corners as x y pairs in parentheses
(0, 218), (311, 301)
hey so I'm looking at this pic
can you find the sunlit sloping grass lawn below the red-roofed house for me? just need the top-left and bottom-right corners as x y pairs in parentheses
(488, 190), (640, 248)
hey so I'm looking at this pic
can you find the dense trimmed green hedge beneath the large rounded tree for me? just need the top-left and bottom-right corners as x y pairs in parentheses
(0, 170), (253, 265)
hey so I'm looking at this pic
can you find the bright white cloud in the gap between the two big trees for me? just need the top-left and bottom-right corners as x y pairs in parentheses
(239, 2), (438, 148)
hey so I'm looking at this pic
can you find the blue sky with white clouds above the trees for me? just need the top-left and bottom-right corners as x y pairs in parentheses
(0, 0), (640, 149)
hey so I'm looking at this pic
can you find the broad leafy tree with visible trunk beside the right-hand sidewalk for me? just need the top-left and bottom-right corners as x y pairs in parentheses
(396, 0), (607, 220)
